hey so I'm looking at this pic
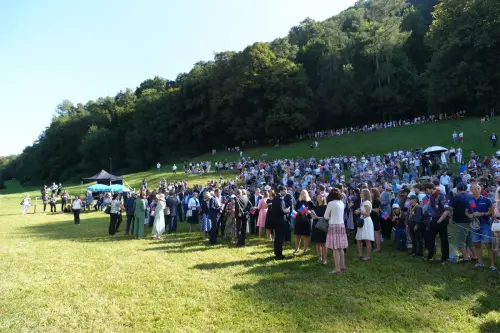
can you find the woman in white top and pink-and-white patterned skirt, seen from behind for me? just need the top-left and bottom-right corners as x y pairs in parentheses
(323, 188), (346, 274)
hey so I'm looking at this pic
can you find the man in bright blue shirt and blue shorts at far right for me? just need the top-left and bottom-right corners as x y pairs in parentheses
(470, 183), (497, 272)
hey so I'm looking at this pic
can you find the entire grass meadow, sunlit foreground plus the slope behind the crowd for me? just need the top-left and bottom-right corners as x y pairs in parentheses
(0, 121), (500, 333)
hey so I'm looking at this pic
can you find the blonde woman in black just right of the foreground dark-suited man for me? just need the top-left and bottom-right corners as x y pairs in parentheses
(293, 190), (314, 255)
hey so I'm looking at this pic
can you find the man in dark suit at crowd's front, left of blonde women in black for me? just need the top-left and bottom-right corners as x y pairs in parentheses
(271, 186), (290, 260)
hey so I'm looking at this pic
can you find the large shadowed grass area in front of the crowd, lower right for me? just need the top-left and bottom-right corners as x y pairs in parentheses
(191, 250), (500, 332)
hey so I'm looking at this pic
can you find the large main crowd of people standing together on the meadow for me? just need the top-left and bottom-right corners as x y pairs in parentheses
(62, 143), (500, 274)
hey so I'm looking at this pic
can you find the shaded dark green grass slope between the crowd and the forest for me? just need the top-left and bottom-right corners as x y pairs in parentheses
(192, 118), (500, 166)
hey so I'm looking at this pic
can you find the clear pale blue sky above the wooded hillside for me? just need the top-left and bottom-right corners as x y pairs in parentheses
(0, 0), (355, 156)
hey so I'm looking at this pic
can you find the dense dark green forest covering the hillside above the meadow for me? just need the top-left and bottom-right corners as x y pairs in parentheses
(3, 0), (500, 181)
